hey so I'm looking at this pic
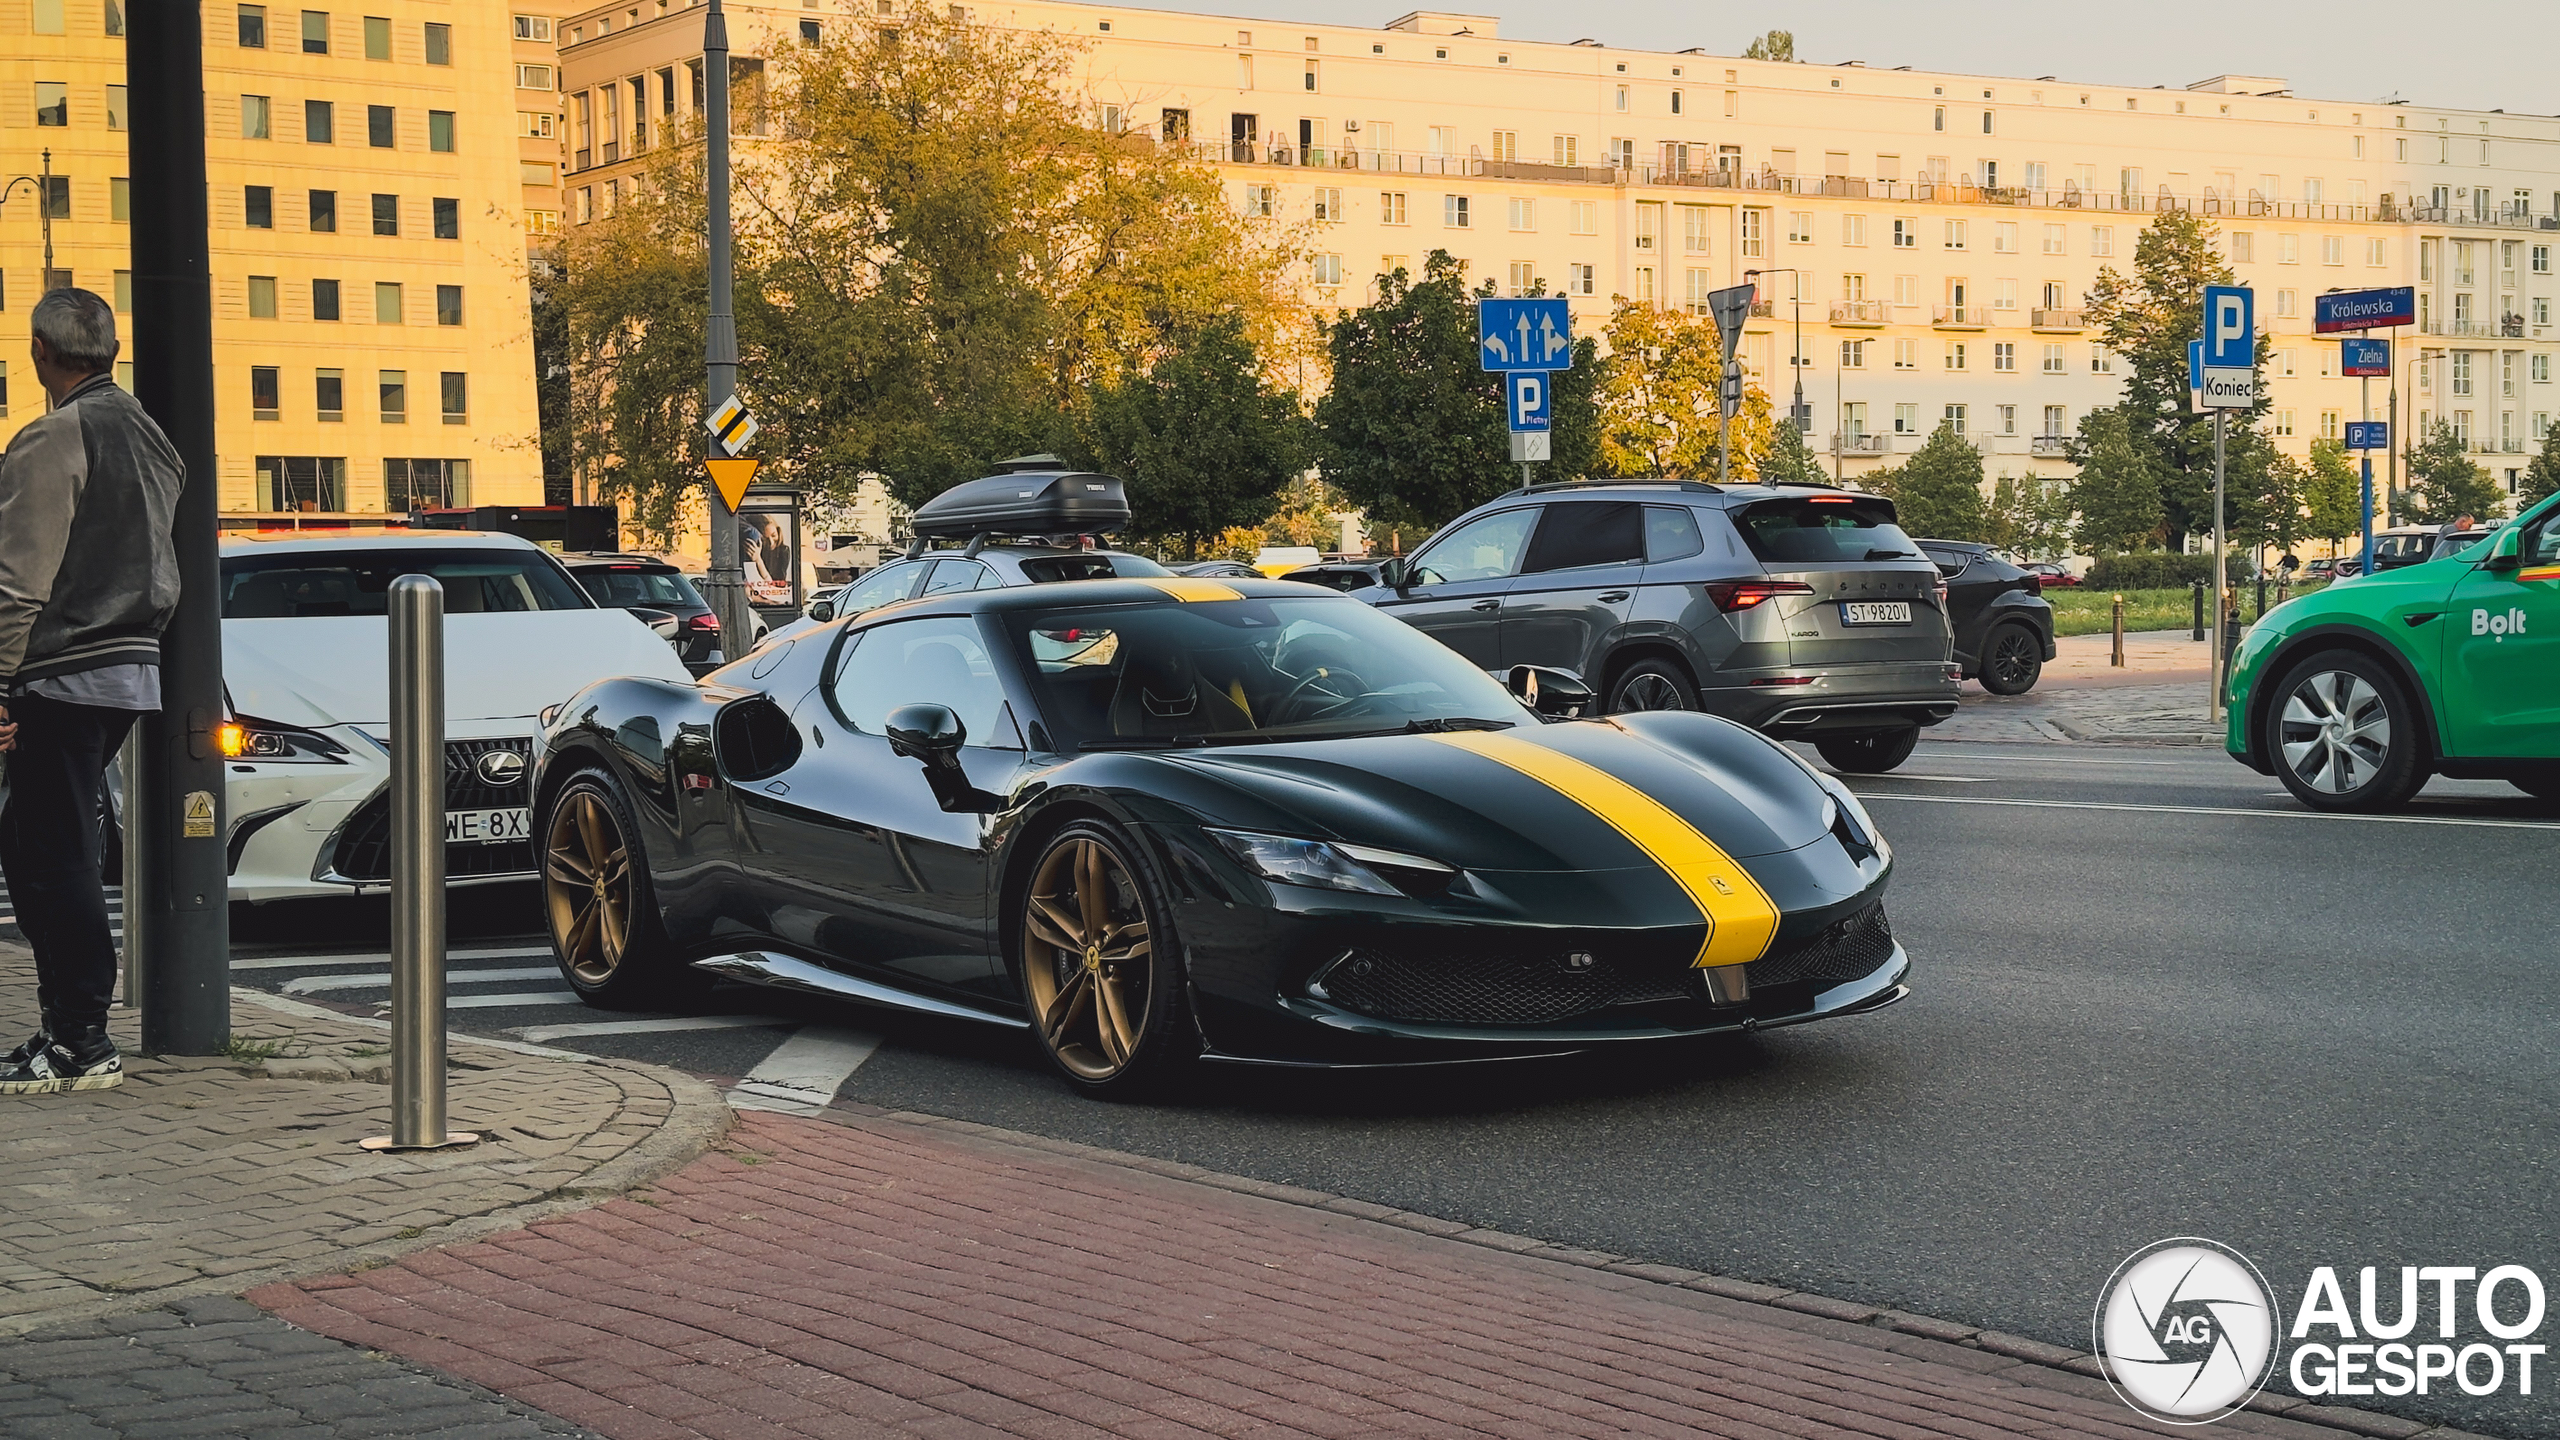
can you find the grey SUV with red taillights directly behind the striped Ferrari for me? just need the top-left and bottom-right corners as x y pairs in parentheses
(1352, 479), (1956, 771)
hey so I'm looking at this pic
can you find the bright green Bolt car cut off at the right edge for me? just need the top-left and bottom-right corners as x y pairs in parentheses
(2225, 497), (2560, 810)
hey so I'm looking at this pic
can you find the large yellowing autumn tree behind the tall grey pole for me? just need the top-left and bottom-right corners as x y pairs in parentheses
(561, 10), (1303, 536)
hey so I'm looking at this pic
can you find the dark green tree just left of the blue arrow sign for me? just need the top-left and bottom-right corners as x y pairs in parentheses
(1316, 251), (1518, 533)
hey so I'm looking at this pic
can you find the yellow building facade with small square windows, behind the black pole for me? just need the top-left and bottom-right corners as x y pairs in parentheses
(0, 0), (558, 525)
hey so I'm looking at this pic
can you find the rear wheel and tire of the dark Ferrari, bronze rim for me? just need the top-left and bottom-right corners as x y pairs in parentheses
(535, 771), (712, 1010)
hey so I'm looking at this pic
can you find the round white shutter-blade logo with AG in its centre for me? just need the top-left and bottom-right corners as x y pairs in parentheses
(2092, 1235), (2278, 1425)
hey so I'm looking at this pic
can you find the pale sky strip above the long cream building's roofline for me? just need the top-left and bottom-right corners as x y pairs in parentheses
(1116, 0), (2560, 115)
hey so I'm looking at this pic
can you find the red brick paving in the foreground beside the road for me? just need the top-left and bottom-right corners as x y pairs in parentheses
(248, 1112), (2452, 1440)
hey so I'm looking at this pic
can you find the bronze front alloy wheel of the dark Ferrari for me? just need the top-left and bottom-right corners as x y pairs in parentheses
(1021, 833), (1160, 1081)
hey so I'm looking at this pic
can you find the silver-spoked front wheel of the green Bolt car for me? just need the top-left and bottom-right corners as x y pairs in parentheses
(2266, 651), (2427, 812)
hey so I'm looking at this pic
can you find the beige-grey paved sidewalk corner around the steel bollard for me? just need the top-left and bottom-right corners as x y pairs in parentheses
(0, 945), (730, 1332)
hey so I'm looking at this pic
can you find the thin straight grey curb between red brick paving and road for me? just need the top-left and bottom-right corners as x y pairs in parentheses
(809, 1099), (2488, 1440)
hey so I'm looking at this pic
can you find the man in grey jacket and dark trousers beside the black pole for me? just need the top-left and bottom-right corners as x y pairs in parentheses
(0, 290), (187, 1094)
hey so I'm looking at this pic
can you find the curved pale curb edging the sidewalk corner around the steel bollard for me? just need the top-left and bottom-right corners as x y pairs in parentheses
(0, 989), (732, 1338)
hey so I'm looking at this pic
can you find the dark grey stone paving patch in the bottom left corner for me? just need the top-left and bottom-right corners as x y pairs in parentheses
(0, 1299), (594, 1440)
